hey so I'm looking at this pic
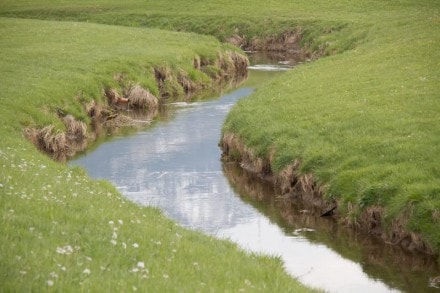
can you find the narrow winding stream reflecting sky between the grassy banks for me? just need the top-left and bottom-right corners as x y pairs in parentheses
(70, 55), (440, 292)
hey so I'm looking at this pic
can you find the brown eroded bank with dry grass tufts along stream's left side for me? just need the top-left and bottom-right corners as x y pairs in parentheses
(23, 51), (249, 161)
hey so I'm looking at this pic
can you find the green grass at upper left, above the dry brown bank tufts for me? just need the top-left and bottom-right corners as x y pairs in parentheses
(0, 19), (234, 132)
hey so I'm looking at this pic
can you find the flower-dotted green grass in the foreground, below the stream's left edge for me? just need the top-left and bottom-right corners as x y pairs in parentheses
(0, 138), (312, 292)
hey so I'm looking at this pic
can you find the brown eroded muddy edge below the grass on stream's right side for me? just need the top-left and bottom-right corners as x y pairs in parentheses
(220, 133), (433, 255)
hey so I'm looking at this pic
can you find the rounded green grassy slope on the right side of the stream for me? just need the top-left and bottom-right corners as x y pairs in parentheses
(224, 3), (440, 253)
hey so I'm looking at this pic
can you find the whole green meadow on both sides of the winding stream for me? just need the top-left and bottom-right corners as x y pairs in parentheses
(0, 0), (440, 292)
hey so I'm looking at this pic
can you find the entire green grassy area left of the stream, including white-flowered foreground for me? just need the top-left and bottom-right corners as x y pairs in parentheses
(0, 18), (307, 292)
